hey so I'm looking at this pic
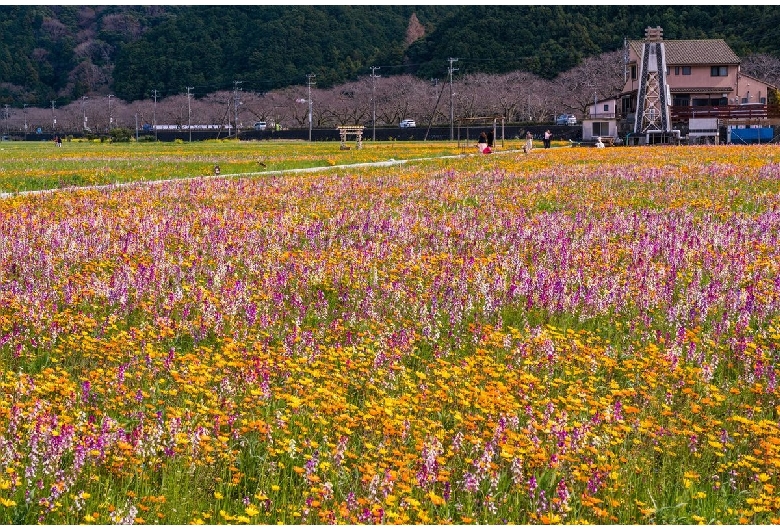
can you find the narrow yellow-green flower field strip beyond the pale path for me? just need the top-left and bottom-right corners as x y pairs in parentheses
(0, 141), (476, 194)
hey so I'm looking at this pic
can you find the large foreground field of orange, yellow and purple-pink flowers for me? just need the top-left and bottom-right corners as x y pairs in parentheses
(0, 144), (780, 524)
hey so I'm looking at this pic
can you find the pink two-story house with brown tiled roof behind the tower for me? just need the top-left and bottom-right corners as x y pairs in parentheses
(583, 28), (777, 140)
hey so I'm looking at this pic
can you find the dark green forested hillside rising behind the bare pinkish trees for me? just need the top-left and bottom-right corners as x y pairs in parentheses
(0, 5), (780, 106)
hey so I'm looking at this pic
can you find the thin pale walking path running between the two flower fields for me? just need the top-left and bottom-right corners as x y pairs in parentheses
(0, 149), (522, 199)
